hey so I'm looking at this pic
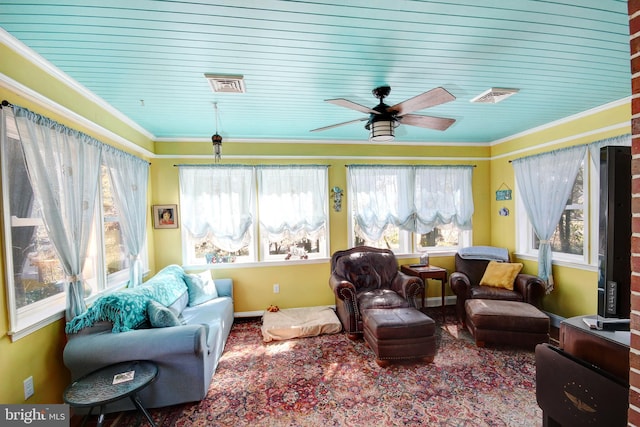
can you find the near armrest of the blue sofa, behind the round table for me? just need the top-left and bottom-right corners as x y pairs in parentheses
(63, 325), (208, 379)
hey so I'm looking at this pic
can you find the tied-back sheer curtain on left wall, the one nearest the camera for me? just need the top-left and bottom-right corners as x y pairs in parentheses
(13, 106), (102, 320)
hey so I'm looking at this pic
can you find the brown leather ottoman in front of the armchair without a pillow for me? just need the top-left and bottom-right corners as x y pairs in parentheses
(362, 308), (436, 367)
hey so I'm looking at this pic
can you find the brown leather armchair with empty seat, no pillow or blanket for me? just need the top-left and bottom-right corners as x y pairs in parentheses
(329, 246), (424, 339)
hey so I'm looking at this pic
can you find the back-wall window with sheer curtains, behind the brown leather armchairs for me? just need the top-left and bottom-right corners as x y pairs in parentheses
(348, 165), (473, 254)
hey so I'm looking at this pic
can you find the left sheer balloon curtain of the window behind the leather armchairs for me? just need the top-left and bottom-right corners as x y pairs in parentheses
(348, 165), (414, 241)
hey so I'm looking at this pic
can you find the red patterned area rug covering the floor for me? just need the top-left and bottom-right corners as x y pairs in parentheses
(107, 308), (542, 426)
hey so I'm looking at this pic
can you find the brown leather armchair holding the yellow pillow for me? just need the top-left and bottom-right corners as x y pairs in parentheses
(449, 254), (545, 325)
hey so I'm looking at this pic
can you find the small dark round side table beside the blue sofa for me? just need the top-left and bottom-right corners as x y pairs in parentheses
(62, 360), (158, 427)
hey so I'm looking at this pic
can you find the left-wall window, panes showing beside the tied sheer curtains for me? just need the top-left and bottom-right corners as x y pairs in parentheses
(0, 109), (139, 340)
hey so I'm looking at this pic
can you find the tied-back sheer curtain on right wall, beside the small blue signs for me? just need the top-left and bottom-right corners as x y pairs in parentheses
(512, 145), (586, 293)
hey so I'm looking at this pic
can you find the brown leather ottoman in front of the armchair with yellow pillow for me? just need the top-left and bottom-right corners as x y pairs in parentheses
(465, 299), (549, 349)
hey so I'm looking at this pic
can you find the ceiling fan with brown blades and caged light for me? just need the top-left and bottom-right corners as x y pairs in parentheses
(311, 86), (456, 142)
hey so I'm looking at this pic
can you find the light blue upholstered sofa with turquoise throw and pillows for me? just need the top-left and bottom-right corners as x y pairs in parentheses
(64, 265), (234, 412)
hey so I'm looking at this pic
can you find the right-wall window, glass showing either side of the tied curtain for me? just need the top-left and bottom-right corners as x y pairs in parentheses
(516, 153), (598, 264)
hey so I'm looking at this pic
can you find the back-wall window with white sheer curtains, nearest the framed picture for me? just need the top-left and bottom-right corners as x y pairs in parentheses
(180, 165), (328, 265)
